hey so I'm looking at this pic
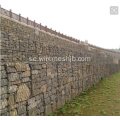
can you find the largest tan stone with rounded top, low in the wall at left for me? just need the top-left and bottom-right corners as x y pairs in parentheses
(16, 84), (30, 102)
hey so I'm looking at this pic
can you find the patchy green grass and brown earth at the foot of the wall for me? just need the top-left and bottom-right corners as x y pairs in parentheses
(50, 72), (120, 116)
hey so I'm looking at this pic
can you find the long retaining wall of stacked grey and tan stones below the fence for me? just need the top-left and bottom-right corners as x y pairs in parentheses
(0, 17), (120, 116)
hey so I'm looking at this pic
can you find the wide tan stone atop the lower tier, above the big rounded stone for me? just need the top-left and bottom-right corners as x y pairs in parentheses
(15, 63), (30, 72)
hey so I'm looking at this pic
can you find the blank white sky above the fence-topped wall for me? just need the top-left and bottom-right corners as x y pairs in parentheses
(0, 0), (120, 49)
